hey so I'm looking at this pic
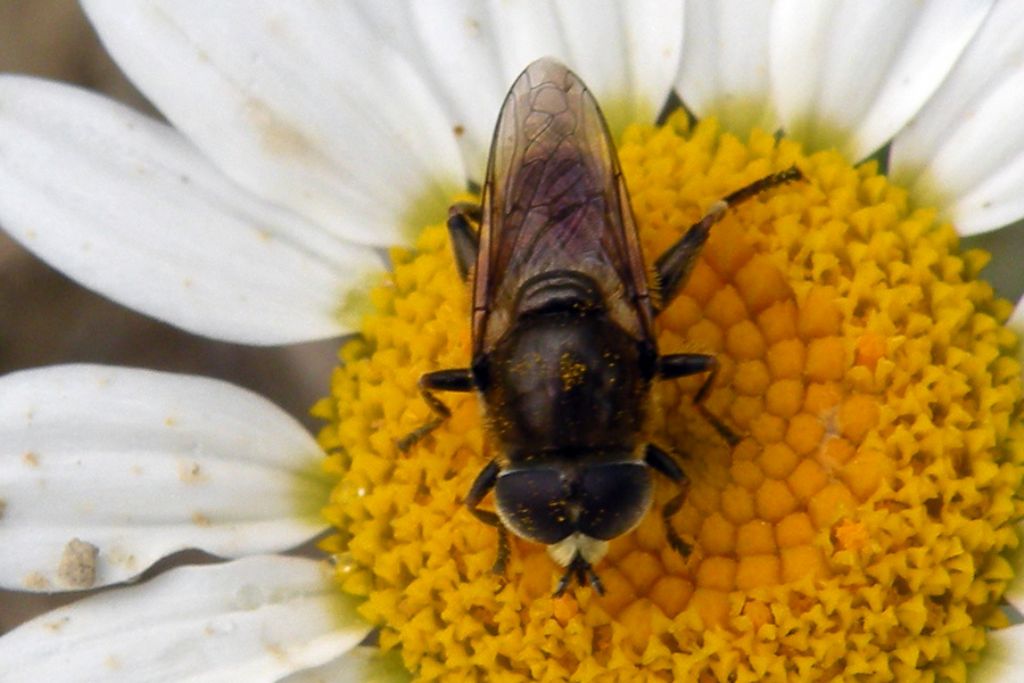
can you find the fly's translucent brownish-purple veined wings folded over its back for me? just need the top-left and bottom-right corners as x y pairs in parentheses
(473, 58), (653, 355)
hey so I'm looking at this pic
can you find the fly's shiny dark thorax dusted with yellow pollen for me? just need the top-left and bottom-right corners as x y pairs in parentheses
(474, 278), (651, 453)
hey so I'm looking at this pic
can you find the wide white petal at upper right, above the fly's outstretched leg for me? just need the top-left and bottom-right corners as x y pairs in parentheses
(771, 0), (992, 159)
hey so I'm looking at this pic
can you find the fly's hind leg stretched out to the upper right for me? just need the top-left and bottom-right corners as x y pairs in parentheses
(654, 166), (804, 310)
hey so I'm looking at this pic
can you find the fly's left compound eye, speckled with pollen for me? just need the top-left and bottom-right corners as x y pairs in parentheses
(495, 468), (573, 545)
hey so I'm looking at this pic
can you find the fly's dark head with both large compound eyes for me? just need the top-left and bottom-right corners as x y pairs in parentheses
(495, 451), (652, 548)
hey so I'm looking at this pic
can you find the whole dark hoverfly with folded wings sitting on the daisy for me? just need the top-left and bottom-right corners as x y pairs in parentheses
(398, 58), (801, 596)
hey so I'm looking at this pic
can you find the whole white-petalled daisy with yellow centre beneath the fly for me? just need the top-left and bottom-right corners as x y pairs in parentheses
(0, 0), (1024, 681)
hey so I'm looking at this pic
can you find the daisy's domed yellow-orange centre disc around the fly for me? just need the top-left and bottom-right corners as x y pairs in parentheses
(317, 116), (1024, 681)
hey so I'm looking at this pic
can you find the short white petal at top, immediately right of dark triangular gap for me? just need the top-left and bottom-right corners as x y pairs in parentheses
(677, 0), (778, 135)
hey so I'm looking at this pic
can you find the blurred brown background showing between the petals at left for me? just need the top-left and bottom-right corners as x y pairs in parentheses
(0, 0), (337, 633)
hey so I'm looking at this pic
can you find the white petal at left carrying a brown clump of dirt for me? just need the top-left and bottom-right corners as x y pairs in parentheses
(0, 366), (329, 593)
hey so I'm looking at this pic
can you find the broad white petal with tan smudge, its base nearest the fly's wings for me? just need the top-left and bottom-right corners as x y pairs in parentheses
(84, 0), (465, 245)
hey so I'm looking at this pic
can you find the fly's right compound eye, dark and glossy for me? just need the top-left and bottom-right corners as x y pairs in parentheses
(577, 463), (651, 541)
